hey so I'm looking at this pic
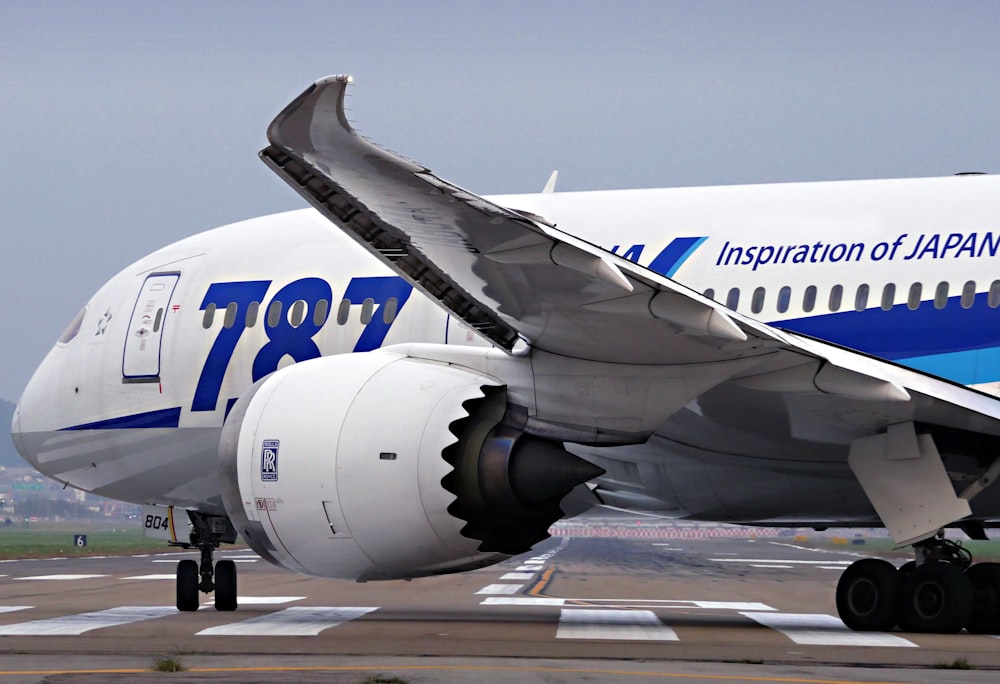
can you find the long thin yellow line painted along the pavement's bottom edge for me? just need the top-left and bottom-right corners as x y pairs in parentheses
(0, 665), (916, 684)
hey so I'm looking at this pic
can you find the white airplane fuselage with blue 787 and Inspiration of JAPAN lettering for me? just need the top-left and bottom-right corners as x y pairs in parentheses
(13, 176), (1000, 520)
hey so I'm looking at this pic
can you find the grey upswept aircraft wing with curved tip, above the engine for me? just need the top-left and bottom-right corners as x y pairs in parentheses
(260, 76), (1000, 544)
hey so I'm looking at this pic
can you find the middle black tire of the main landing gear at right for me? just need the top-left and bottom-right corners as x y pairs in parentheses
(899, 561), (975, 634)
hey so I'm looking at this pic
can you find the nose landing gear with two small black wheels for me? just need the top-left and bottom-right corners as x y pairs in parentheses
(171, 511), (236, 611)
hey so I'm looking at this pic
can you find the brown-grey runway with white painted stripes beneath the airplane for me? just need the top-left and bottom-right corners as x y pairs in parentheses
(0, 537), (1000, 683)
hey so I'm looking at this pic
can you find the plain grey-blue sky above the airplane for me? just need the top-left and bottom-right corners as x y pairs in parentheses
(0, 0), (1000, 400)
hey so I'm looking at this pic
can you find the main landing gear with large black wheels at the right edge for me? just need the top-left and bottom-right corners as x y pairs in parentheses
(837, 533), (1000, 634)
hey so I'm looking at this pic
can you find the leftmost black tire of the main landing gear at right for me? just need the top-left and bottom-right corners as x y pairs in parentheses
(837, 558), (899, 632)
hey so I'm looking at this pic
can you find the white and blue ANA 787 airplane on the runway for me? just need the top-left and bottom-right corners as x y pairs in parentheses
(12, 76), (1000, 634)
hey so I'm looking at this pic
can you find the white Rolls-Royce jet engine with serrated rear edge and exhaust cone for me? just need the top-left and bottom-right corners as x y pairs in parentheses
(220, 351), (603, 580)
